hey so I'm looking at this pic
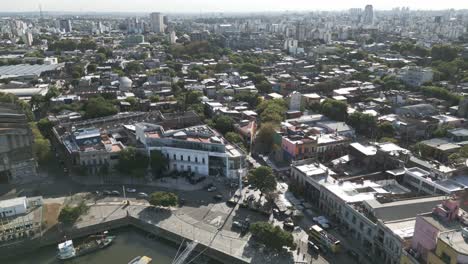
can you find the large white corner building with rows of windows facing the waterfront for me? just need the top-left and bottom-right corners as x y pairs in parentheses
(135, 123), (246, 179)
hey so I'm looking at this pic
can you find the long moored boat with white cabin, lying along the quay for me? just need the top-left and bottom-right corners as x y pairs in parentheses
(57, 231), (115, 260)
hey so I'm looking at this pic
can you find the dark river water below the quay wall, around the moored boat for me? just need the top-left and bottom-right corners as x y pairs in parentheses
(4, 228), (211, 264)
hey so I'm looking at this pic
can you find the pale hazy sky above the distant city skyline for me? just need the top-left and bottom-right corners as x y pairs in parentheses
(0, 0), (468, 13)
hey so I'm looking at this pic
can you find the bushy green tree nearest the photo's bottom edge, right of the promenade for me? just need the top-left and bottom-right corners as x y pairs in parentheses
(250, 222), (296, 250)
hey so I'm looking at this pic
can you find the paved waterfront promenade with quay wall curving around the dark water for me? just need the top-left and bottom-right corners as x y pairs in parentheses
(0, 204), (250, 264)
